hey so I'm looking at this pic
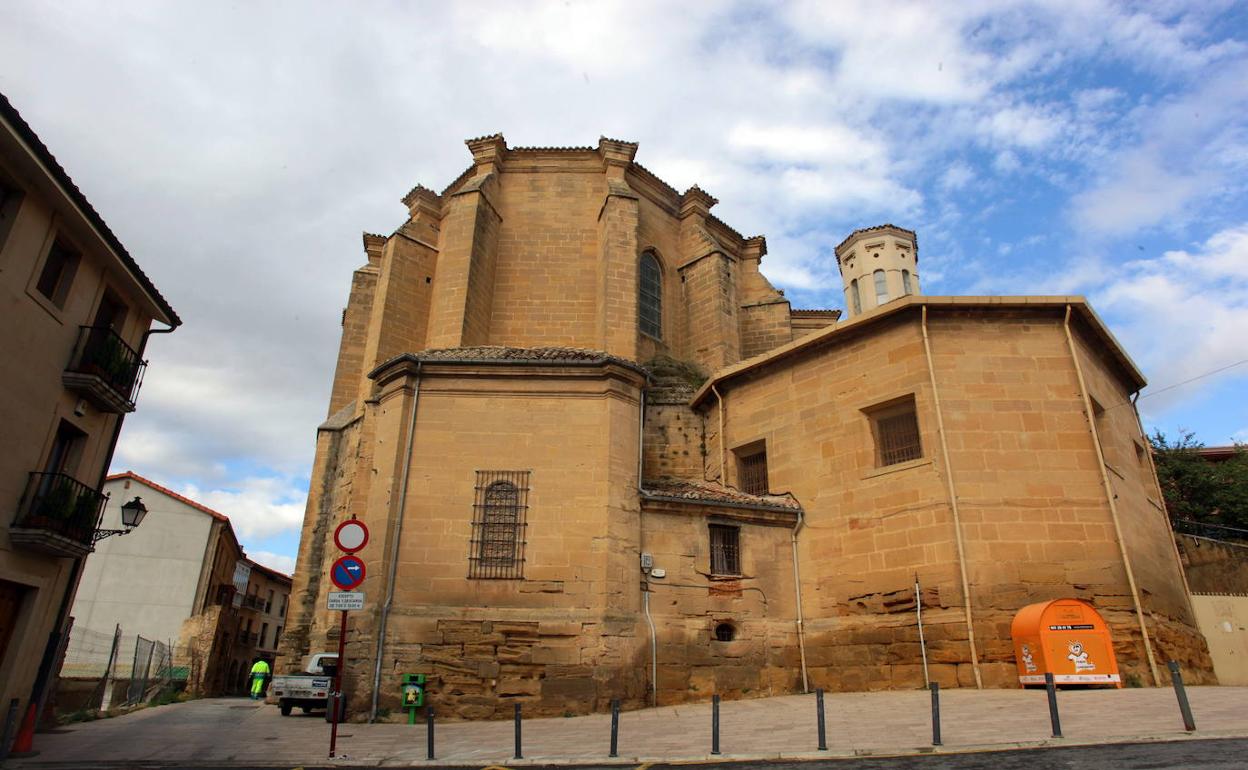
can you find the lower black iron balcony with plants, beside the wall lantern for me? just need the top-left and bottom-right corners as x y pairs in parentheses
(9, 472), (109, 557)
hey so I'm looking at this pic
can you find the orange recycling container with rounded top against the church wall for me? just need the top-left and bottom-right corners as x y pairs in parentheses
(1010, 599), (1122, 688)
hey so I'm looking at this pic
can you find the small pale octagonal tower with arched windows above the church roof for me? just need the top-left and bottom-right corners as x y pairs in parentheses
(836, 225), (921, 317)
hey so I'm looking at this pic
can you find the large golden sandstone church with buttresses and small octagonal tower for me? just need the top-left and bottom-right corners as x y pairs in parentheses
(278, 135), (1212, 719)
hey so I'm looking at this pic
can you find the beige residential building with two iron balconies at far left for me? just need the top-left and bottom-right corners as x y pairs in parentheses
(0, 96), (181, 723)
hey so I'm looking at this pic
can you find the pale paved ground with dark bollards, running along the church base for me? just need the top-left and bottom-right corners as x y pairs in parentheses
(6, 688), (1248, 768)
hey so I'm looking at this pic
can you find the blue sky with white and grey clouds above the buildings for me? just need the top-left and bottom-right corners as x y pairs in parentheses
(0, 0), (1248, 569)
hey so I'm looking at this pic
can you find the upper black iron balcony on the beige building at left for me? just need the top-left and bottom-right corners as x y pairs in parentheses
(61, 326), (147, 414)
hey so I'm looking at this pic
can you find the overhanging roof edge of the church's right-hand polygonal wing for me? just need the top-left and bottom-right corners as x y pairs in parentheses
(689, 295), (1148, 407)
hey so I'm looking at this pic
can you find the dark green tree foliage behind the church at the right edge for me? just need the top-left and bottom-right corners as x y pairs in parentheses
(1148, 431), (1248, 529)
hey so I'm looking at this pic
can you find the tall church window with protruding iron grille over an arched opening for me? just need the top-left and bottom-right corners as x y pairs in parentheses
(468, 470), (529, 580)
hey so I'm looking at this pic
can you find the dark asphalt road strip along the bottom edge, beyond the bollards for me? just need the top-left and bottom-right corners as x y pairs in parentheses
(48, 739), (1248, 770)
